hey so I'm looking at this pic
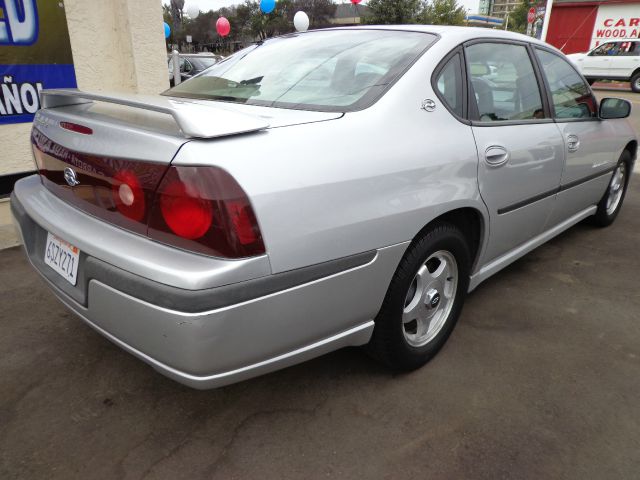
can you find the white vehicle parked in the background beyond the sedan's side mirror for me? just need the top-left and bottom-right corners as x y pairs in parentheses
(567, 40), (640, 93)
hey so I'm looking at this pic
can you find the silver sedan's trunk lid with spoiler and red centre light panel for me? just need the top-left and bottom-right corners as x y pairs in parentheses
(31, 90), (341, 246)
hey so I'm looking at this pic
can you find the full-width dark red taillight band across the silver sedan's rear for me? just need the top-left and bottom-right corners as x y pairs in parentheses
(31, 128), (265, 258)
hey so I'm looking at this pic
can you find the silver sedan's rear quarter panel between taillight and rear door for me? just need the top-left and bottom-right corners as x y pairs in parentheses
(174, 44), (486, 273)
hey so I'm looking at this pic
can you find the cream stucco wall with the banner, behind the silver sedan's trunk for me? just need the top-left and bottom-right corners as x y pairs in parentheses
(0, 0), (169, 175)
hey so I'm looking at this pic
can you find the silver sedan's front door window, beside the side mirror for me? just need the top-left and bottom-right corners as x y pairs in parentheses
(536, 49), (598, 118)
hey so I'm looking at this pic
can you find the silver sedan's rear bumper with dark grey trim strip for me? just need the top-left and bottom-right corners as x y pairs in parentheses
(11, 179), (407, 388)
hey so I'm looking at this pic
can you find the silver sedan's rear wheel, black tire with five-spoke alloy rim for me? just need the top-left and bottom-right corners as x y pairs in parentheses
(367, 222), (471, 371)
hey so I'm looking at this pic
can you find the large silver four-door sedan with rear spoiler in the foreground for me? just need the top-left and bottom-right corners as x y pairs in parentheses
(11, 25), (638, 388)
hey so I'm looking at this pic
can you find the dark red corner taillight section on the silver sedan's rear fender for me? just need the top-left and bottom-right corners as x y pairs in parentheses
(148, 167), (265, 258)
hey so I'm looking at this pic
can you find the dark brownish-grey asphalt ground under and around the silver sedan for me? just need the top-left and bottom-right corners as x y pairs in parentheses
(0, 174), (640, 480)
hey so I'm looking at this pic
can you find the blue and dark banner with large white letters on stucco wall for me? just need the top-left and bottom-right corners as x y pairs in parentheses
(0, 0), (77, 125)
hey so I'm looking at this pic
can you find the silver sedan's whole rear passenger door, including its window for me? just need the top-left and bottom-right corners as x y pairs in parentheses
(465, 40), (564, 263)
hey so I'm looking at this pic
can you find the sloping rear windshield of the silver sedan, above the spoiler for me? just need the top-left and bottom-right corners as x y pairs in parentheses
(164, 30), (436, 111)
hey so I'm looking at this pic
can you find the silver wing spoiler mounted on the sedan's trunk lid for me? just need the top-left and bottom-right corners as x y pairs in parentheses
(40, 89), (269, 138)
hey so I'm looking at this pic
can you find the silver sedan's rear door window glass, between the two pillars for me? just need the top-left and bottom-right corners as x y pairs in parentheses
(465, 43), (544, 122)
